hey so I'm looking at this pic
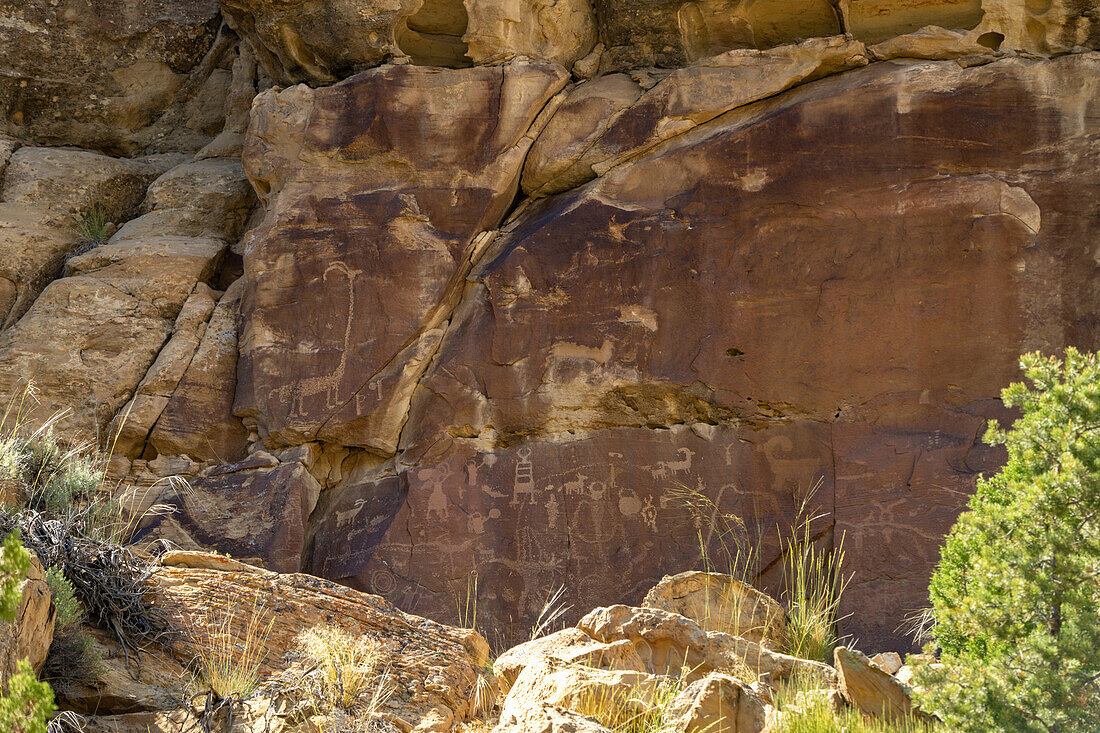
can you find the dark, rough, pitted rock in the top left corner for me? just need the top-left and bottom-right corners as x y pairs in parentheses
(0, 0), (232, 153)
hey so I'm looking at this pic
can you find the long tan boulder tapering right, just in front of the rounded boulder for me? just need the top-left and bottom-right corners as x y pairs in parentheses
(576, 605), (834, 682)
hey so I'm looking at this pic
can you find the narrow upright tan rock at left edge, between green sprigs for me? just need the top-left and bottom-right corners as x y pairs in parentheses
(0, 553), (55, 688)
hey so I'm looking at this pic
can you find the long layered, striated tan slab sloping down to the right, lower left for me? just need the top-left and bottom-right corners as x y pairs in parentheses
(154, 553), (488, 733)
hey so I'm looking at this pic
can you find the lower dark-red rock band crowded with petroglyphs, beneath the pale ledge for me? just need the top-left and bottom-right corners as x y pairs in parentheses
(314, 424), (833, 637)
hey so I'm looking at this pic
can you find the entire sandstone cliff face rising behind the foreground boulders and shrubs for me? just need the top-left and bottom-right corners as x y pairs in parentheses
(0, 0), (1100, 646)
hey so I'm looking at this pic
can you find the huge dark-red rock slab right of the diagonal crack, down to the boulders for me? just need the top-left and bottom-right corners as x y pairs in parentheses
(332, 54), (1100, 647)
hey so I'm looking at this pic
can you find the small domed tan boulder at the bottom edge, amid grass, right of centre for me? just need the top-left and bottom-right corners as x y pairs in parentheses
(662, 672), (766, 733)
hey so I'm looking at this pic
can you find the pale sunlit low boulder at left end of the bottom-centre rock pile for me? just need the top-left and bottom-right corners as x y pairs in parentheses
(493, 628), (647, 691)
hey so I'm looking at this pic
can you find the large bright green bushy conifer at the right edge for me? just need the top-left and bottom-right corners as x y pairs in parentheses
(917, 349), (1100, 733)
